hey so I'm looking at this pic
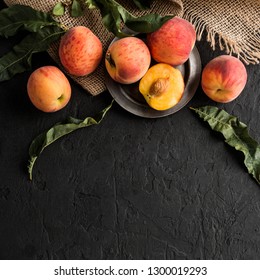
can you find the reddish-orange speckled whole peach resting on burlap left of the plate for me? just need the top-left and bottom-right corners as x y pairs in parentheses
(59, 26), (103, 76)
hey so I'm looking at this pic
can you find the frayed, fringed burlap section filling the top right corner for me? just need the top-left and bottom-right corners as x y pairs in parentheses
(183, 0), (260, 64)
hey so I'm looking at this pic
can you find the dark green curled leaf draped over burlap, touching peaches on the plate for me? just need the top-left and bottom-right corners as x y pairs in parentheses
(85, 0), (173, 37)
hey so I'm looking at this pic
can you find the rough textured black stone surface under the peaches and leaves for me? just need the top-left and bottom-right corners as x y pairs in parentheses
(0, 1), (260, 259)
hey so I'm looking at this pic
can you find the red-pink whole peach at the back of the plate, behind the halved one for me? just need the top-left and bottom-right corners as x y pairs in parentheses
(147, 17), (196, 66)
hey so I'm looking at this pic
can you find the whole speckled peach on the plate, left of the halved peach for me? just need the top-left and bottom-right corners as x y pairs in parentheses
(105, 37), (151, 84)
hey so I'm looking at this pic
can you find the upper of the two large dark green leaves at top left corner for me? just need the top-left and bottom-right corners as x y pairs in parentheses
(0, 5), (58, 38)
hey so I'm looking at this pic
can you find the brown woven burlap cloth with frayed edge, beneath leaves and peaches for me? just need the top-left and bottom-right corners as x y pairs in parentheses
(4, 0), (260, 95)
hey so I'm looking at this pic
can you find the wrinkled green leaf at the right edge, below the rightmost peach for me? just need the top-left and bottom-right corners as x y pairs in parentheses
(191, 106), (260, 184)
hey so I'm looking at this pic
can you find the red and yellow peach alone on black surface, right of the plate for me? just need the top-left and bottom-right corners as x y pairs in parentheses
(201, 55), (247, 103)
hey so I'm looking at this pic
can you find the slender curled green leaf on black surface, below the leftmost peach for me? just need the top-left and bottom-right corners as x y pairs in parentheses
(28, 100), (114, 180)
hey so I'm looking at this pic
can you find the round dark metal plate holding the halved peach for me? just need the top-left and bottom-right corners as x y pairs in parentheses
(105, 38), (201, 118)
